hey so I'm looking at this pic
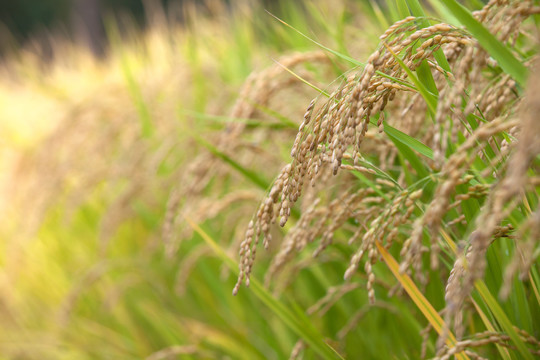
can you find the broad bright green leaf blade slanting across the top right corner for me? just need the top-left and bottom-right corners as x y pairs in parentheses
(440, 0), (528, 86)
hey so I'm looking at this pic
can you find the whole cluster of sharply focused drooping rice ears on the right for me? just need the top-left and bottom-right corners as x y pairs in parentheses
(235, 0), (540, 356)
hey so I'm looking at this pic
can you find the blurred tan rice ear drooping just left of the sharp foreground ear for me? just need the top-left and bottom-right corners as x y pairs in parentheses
(162, 51), (331, 254)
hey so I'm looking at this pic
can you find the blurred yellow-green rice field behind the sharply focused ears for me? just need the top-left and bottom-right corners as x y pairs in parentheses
(0, 0), (540, 360)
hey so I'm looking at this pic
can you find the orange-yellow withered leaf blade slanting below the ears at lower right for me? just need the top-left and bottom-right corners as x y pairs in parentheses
(375, 241), (469, 359)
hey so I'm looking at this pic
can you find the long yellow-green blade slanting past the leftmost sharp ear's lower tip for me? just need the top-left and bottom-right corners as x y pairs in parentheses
(185, 217), (342, 359)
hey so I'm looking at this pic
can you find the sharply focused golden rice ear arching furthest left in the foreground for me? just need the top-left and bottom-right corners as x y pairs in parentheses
(234, 17), (469, 292)
